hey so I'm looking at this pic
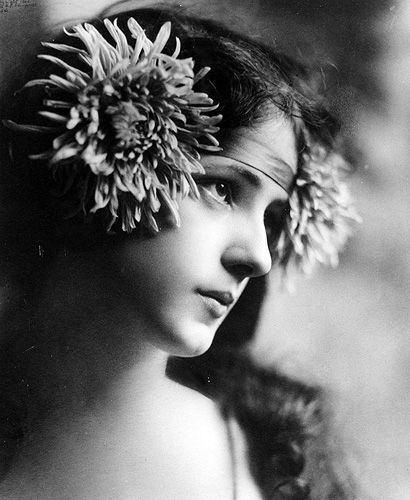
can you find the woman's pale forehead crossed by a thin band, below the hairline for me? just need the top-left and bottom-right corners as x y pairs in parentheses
(217, 118), (297, 192)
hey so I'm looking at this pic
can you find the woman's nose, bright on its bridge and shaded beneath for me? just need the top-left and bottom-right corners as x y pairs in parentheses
(221, 220), (272, 279)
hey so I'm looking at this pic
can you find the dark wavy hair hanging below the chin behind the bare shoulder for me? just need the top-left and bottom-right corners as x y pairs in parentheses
(168, 276), (357, 500)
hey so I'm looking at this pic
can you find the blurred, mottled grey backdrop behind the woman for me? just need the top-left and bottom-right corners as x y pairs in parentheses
(0, 0), (410, 500)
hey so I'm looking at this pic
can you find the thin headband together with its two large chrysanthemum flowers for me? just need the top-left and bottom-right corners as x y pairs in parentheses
(4, 18), (357, 272)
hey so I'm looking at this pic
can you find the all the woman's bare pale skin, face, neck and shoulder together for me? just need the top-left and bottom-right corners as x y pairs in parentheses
(0, 118), (297, 500)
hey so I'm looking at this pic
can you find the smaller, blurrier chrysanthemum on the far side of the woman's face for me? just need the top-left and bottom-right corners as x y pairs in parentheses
(276, 144), (360, 273)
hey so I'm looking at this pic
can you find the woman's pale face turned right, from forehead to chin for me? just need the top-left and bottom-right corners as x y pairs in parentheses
(115, 115), (297, 356)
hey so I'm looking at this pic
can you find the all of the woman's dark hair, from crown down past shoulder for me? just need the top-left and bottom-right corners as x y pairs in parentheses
(0, 4), (356, 500)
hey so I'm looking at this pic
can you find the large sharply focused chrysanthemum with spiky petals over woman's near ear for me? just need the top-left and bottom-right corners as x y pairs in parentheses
(4, 18), (221, 231)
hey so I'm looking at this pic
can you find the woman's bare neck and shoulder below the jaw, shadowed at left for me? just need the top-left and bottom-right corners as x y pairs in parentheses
(0, 254), (237, 500)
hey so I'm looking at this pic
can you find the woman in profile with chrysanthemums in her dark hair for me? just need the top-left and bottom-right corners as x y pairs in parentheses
(0, 4), (354, 500)
